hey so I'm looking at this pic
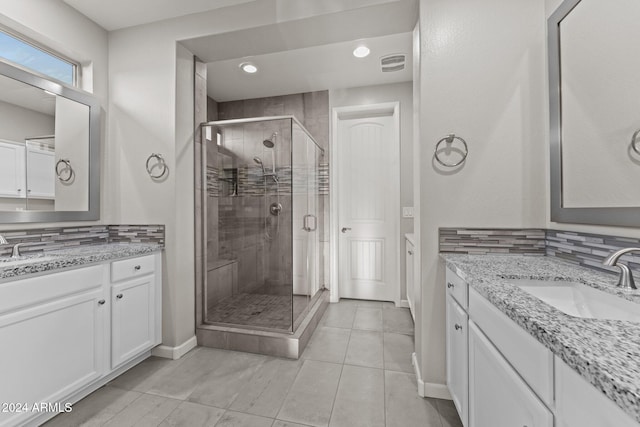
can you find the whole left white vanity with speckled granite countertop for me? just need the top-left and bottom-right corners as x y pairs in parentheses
(0, 244), (162, 426)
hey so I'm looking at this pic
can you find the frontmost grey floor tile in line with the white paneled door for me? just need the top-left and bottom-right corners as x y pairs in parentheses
(329, 365), (385, 427)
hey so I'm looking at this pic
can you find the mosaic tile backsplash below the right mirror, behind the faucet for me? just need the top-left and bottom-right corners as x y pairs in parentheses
(546, 230), (640, 272)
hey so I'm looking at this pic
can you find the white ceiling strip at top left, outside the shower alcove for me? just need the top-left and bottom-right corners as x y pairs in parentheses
(63, 0), (254, 31)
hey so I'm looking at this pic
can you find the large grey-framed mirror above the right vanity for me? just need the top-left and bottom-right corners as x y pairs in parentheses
(548, 0), (640, 226)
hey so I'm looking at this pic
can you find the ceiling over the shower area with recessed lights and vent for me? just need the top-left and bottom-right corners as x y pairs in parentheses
(207, 33), (413, 102)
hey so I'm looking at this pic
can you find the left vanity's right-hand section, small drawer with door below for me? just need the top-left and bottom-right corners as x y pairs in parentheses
(111, 255), (160, 369)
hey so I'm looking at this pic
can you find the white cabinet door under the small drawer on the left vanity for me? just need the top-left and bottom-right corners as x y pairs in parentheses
(111, 275), (155, 368)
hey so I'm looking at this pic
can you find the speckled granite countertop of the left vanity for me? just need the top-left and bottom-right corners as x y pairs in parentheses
(0, 243), (162, 281)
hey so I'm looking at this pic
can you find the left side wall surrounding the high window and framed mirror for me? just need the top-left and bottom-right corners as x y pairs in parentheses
(0, 0), (109, 230)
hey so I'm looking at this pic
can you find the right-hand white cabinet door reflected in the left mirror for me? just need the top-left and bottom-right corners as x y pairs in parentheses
(27, 147), (56, 199)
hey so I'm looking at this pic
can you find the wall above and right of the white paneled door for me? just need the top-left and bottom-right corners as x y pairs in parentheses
(329, 82), (413, 299)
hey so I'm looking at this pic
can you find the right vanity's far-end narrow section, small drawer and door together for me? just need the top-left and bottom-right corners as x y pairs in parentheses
(446, 270), (469, 427)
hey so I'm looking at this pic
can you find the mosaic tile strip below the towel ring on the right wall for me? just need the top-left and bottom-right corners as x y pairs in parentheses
(439, 228), (545, 255)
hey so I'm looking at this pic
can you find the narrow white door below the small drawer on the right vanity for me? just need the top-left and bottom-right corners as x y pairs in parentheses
(446, 295), (469, 426)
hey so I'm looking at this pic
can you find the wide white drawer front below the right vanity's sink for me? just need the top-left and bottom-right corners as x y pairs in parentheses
(469, 289), (553, 406)
